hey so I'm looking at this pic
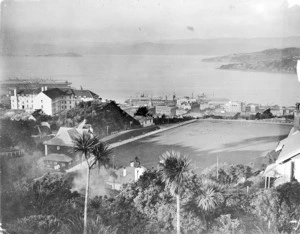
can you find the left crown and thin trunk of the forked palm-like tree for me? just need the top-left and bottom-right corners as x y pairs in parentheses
(74, 133), (100, 234)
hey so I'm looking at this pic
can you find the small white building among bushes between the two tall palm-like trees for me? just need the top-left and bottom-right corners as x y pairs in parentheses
(105, 161), (147, 190)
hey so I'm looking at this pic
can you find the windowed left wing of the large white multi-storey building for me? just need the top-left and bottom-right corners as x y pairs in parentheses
(10, 87), (42, 110)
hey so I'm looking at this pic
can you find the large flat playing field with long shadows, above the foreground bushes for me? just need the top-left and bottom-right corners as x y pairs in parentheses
(113, 120), (291, 172)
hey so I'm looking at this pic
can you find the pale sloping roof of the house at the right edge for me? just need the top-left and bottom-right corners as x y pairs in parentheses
(276, 131), (300, 163)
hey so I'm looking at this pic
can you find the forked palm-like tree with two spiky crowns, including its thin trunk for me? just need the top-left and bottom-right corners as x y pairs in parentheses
(74, 133), (111, 234)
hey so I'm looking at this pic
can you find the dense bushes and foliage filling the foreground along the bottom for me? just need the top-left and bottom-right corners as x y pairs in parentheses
(2, 158), (300, 234)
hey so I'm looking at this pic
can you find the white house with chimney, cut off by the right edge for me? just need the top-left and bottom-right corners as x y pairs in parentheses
(264, 103), (300, 187)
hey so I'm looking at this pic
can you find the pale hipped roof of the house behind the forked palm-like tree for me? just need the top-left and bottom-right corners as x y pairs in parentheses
(44, 127), (88, 147)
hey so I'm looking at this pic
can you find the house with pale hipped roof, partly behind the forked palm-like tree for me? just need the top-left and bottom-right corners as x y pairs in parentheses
(43, 127), (92, 161)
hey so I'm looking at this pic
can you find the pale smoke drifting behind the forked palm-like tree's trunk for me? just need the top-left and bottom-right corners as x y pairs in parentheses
(71, 167), (109, 198)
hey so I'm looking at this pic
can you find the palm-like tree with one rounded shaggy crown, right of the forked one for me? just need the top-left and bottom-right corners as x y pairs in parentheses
(159, 151), (190, 234)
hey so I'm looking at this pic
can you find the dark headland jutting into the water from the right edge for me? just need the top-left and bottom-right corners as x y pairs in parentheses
(203, 47), (300, 73)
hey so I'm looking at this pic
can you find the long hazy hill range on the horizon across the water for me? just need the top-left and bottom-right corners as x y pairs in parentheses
(3, 36), (300, 56)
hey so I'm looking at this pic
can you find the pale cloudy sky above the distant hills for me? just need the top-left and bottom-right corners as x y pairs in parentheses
(4, 0), (300, 43)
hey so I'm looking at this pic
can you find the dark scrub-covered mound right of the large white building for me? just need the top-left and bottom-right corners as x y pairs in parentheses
(63, 101), (140, 137)
